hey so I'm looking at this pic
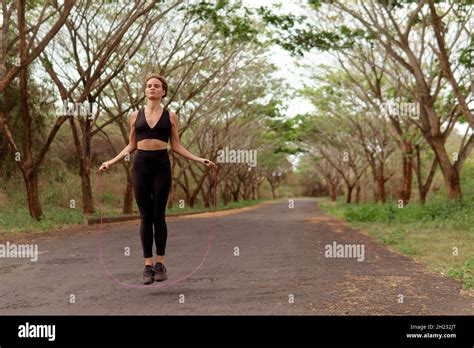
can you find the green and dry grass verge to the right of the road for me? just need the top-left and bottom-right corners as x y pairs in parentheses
(320, 195), (474, 289)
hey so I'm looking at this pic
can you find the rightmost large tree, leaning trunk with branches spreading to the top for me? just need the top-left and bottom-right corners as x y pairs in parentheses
(326, 0), (474, 200)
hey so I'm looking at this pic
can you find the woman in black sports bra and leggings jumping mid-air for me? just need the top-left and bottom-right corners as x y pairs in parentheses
(99, 74), (215, 284)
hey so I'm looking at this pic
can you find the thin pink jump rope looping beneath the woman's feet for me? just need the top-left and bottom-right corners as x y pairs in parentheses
(99, 161), (217, 288)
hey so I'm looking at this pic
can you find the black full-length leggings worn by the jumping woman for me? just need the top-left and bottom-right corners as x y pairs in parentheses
(132, 149), (171, 258)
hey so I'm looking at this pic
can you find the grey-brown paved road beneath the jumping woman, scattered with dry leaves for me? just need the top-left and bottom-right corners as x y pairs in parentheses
(0, 199), (474, 315)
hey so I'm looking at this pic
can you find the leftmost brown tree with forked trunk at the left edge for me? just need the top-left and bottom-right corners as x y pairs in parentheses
(0, 0), (74, 220)
